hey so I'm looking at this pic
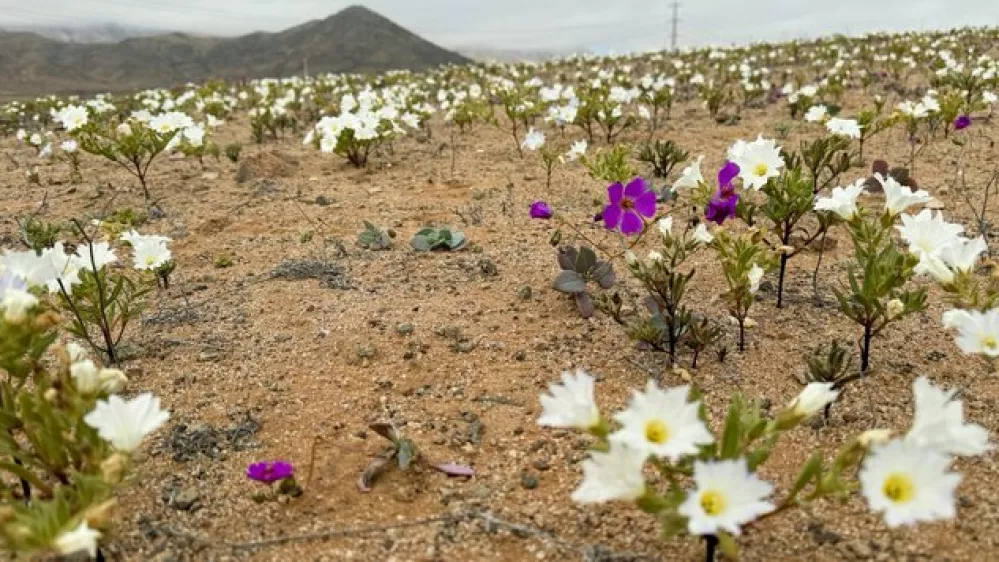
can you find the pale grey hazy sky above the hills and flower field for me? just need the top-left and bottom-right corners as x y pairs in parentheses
(0, 0), (999, 52)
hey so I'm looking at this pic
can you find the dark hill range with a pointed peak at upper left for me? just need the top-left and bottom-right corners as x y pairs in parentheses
(0, 6), (469, 96)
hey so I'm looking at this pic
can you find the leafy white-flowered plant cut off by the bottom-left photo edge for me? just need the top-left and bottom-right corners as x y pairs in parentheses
(0, 270), (169, 557)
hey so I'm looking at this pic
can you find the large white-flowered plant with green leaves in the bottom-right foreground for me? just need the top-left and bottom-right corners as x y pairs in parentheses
(538, 371), (992, 560)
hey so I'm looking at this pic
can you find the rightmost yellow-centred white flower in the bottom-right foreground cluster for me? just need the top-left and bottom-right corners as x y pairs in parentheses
(859, 439), (961, 527)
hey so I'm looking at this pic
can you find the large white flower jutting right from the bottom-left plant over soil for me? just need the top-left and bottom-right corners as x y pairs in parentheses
(83, 392), (170, 452)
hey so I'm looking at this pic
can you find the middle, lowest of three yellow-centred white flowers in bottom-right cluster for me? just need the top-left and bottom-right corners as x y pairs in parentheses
(677, 459), (774, 535)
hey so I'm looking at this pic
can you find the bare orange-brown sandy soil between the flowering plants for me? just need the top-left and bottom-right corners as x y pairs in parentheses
(0, 91), (999, 562)
